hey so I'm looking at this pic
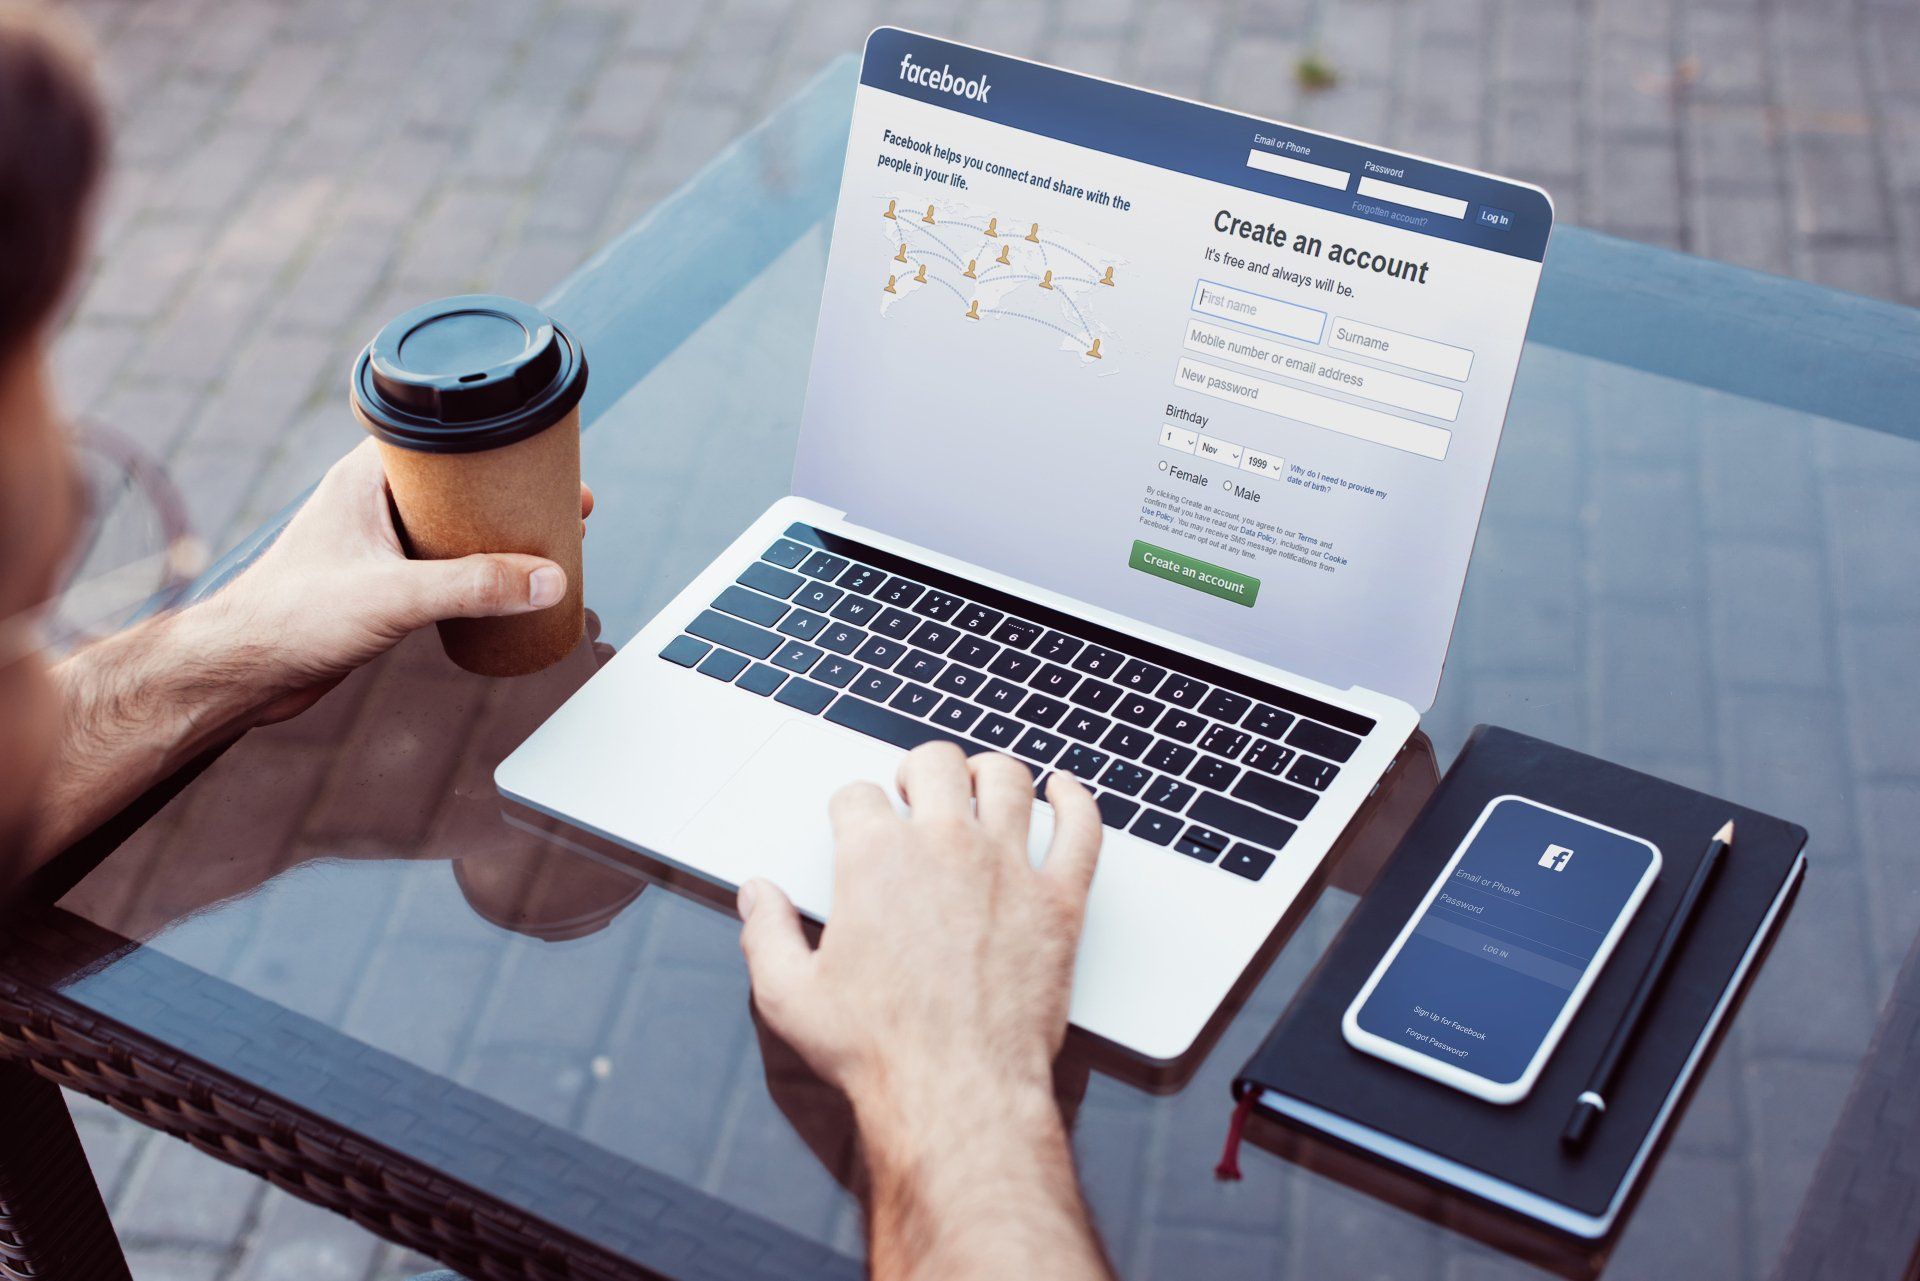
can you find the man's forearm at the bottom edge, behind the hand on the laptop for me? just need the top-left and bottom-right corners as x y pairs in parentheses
(854, 1074), (1112, 1281)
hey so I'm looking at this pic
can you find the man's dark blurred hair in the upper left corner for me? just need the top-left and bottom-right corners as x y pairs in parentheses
(0, 0), (108, 347)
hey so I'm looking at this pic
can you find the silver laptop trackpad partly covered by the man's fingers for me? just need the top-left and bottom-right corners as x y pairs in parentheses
(670, 720), (1054, 920)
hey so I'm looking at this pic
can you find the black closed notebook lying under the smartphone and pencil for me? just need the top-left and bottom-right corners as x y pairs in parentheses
(1235, 726), (1807, 1239)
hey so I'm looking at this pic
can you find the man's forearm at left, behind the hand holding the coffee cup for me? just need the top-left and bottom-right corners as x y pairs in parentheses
(15, 603), (259, 878)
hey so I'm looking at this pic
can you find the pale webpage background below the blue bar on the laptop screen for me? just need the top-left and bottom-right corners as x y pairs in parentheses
(793, 86), (1540, 709)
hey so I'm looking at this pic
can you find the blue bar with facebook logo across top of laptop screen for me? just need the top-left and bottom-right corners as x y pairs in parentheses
(860, 27), (1553, 263)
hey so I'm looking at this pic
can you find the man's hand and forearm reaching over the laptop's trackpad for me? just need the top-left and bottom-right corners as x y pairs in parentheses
(739, 743), (1108, 1277)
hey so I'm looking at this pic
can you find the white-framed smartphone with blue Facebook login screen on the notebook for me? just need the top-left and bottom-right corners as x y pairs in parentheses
(1340, 795), (1661, 1102)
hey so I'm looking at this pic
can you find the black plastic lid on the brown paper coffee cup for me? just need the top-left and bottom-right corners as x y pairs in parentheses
(353, 294), (588, 453)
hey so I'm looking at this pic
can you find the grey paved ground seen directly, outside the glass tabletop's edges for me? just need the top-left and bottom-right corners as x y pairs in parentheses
(37, 0), (1920, 1281)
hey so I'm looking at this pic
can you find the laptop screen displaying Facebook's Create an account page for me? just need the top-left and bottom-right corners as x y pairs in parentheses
(795, 29), (1553, 709)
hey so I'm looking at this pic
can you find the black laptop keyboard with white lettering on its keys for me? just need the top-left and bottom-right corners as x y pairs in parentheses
(660, 524), (1373, 882)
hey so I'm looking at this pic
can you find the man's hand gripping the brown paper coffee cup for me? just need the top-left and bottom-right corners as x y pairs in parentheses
(199, 440), (593, 724)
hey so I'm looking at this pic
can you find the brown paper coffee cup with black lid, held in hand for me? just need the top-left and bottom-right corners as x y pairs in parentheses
(351, 294), (588, 676)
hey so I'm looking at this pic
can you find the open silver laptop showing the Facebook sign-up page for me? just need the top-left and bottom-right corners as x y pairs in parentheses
(495, 27), (1553, 1060)
